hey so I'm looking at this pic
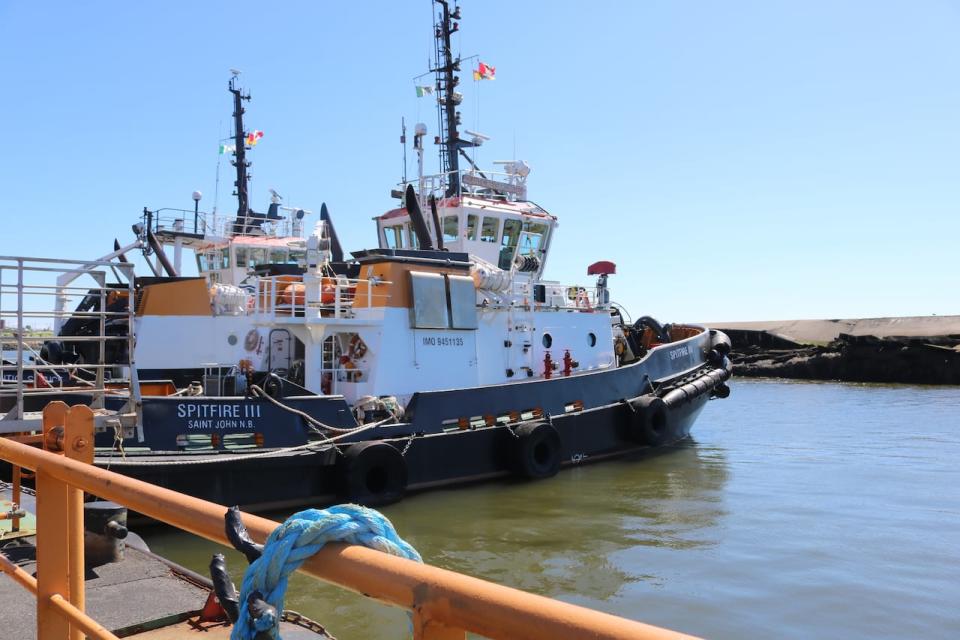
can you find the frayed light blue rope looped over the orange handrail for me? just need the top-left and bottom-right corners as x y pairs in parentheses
(230, 504), (423, 640)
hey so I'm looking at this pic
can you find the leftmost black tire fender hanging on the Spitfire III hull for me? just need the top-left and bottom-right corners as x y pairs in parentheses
(336, 440), (407, 505)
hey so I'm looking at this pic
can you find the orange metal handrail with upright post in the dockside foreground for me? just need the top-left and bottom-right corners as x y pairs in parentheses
(0, 402), (690, 640)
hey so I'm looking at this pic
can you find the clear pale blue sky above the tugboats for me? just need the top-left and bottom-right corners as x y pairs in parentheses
(0, 0), (960, 321)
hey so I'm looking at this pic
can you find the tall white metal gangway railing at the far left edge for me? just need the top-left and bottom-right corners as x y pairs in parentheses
(0, 256), (139, 431)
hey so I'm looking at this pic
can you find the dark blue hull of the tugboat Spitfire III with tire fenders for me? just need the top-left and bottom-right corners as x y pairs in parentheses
(97, 332), (729, 510)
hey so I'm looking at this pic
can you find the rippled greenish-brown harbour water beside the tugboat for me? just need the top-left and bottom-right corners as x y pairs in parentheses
(145, 381), (960, 640)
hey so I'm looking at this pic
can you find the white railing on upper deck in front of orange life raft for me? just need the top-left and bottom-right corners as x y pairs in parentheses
(253, 275), (391, 319)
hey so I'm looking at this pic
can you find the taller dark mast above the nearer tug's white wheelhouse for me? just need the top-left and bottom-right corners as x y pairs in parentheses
(431, 0), (474, 196)
